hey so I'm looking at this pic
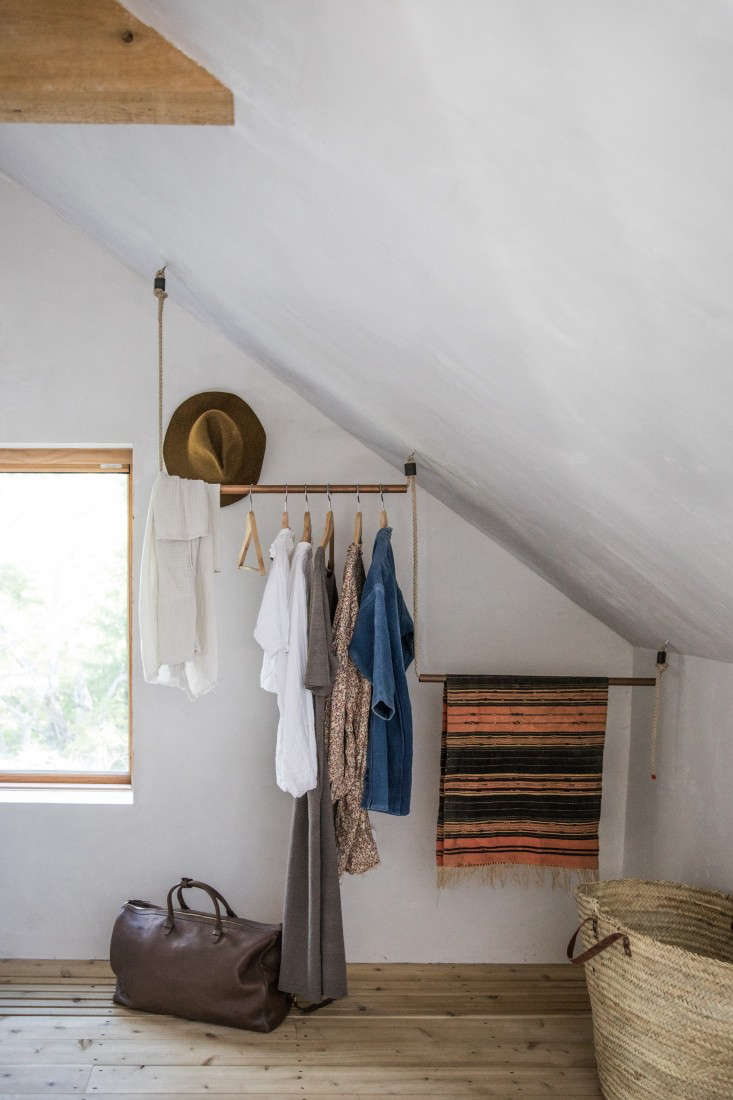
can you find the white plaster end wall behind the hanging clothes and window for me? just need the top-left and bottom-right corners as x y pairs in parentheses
(0, 178), (632, 961)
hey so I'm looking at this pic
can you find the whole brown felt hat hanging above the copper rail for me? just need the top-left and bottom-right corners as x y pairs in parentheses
(163, 393), (266, 506)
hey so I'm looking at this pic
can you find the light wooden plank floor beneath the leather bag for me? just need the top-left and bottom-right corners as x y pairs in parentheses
(0, 959), (601, 1100)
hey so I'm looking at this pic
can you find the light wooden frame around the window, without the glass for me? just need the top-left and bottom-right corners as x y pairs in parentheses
(0, 447), (133, 787)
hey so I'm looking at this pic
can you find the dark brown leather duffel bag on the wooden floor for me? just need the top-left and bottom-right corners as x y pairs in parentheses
(110, 878), (289, 1032)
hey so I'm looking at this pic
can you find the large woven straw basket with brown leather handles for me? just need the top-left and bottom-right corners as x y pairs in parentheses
(568, 879), (733, 1100)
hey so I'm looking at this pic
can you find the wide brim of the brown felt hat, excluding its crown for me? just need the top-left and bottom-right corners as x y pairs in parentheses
(163, 391), (266, 507)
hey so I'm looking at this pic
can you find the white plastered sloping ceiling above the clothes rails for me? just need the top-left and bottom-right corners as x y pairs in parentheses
(0, 0), (733, 660)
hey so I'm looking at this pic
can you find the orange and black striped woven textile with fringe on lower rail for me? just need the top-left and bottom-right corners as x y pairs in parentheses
(436, 677), (609, 886)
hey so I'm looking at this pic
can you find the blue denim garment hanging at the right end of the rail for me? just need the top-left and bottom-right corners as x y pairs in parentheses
(349, 527), (414, 815)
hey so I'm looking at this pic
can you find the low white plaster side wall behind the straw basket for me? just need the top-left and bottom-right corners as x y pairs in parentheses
(624, 649), (733, 891)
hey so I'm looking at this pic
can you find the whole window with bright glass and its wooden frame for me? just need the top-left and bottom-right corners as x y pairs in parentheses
(0, 449), (132, 783)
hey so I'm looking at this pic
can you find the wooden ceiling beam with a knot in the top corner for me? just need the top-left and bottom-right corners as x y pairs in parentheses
(0, 0), (234, 125)
